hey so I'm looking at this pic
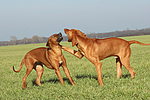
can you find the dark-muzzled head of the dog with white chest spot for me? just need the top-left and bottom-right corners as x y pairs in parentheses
(46, 33), (63, 47)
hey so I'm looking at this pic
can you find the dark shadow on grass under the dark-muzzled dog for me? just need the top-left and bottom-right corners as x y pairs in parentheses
(32, 78), (71, 86)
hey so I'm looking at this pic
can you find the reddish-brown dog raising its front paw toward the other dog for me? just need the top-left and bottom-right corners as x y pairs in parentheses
(63, 29), (150, 86)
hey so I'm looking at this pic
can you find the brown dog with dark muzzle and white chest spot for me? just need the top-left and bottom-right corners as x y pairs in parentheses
(13, 33), (75, 89)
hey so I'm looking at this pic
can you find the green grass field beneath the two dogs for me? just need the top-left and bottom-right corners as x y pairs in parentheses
(0, 35), (150, 100)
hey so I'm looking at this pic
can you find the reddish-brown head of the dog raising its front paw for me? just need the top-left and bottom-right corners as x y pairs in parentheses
(64, 28), (86, 46)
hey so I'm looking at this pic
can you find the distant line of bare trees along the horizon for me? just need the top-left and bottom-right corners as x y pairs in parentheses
(0, 28), (150, 46)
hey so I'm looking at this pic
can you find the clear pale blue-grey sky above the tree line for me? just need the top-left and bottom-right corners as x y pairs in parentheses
(0, 0), (150, 41)
